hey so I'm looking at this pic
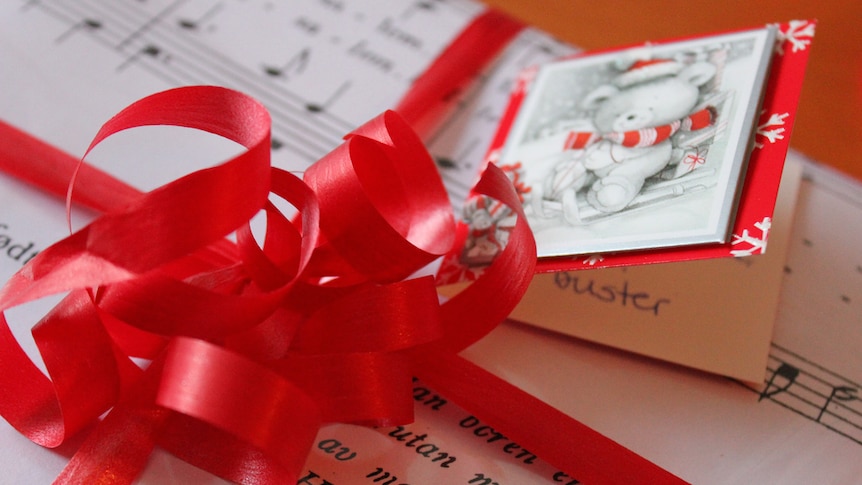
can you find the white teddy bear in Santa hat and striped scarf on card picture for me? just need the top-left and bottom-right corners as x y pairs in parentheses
(553, 59), (716, 215)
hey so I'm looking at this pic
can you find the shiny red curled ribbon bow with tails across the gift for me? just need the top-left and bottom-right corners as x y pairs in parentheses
(0, 9), (678, 483)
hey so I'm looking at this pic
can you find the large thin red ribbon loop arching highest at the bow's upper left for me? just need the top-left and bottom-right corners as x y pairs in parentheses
(77, 87), (270, 273)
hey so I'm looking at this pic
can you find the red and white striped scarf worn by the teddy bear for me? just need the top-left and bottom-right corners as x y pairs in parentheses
(563, 106), (717, 150)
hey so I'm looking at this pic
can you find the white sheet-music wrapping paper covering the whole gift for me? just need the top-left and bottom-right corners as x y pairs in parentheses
(0, 0), (862, 485)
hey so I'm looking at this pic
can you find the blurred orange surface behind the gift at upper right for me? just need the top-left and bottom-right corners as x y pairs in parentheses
(485, 0), (862, 180)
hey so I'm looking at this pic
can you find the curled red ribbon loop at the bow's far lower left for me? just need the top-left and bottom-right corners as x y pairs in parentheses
(0, 292), (140, 448)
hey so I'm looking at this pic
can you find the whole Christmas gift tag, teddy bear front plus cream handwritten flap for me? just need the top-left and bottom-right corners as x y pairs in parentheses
(441, 21), (814, 382)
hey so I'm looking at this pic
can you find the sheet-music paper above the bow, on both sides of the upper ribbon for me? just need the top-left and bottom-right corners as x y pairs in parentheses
(0, 0), (573, 206)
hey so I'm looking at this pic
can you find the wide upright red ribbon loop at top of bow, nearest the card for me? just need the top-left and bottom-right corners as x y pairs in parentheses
(304, 111), (455, 282)
